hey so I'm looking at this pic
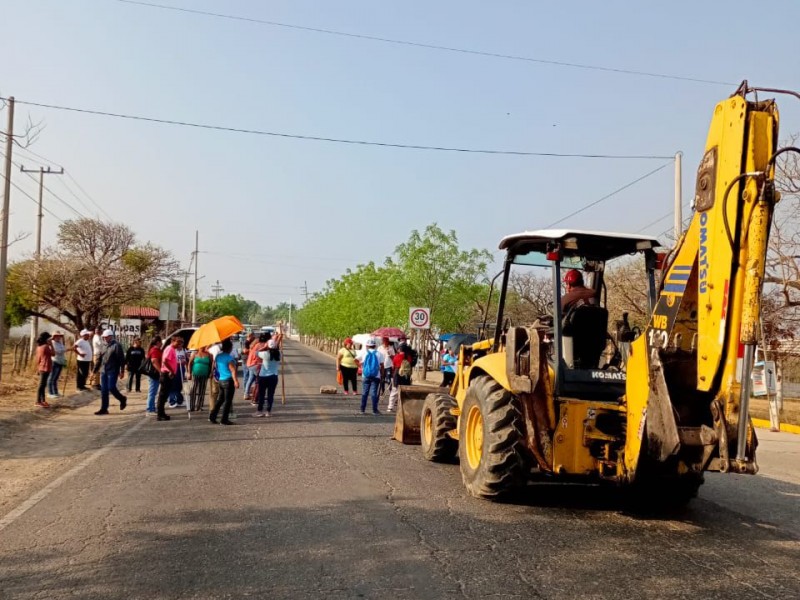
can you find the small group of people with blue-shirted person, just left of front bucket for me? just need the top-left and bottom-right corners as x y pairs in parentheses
(336, 337), (417, 415)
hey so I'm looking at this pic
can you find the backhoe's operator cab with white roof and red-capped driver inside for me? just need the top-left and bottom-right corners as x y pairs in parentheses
(494, 229), (661, 400)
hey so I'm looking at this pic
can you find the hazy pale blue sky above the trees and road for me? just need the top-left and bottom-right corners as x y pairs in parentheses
(0, 0), (800, 304)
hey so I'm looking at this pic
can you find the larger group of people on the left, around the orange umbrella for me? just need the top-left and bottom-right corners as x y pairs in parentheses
(36, 328), (283, 425)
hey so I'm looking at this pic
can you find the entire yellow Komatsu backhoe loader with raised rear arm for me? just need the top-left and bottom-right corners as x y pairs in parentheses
(395, 82), (800, 502)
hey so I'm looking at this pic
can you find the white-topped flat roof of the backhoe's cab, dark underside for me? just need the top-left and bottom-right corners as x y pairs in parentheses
(500, 229), (661, 260)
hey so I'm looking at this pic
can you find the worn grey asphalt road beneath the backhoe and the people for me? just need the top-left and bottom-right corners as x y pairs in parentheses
(0, 343), (800, 599)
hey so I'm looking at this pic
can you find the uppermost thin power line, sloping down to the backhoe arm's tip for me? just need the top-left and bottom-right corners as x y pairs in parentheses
(116, 0), (736, 86)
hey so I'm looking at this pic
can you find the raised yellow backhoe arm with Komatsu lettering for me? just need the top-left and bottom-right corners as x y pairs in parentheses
(625, 86), (778, 472)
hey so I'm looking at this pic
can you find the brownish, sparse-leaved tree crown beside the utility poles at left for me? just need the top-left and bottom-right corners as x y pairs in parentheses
(8, 219), (178, 333)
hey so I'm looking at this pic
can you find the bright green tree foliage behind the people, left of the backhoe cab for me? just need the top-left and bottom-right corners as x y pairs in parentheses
(296, 224), (492, 338)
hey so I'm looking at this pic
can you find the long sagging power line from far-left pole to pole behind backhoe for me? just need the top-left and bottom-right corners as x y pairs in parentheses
(0, 97), (672, 158)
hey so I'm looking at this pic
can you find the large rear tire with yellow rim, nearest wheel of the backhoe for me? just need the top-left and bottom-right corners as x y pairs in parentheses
(458, 375), (530, 500)
